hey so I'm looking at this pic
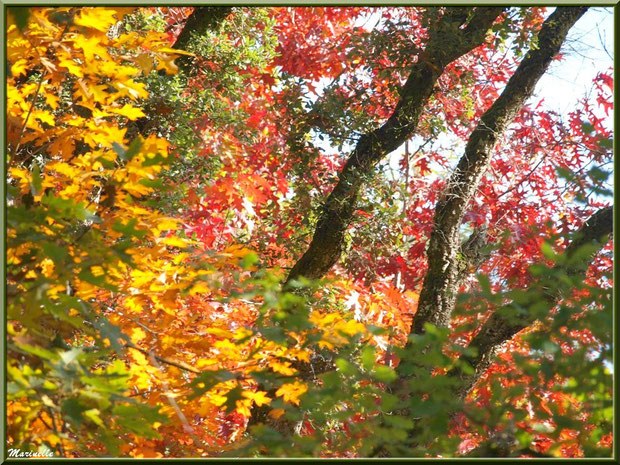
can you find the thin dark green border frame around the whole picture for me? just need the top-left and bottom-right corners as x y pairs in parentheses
(0, 0), (620, 464)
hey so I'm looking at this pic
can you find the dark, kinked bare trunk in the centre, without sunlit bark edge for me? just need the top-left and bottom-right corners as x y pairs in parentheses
(287, 7), (503, 281)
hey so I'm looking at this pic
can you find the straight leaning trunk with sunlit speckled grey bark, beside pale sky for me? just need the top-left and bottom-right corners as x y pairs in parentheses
(411, 7), (587, 334)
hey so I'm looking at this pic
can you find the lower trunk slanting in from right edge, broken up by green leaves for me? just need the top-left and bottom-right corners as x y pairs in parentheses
(449, 207), (613, 397)
